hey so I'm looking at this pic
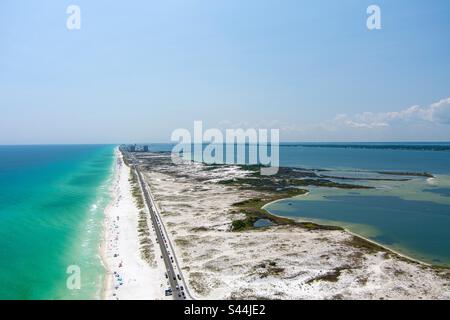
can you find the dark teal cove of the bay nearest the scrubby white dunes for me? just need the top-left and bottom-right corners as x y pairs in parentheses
(267, 190), (450, 264)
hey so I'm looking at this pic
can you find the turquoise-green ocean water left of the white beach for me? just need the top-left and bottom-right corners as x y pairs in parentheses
(0, 145), (114, 299)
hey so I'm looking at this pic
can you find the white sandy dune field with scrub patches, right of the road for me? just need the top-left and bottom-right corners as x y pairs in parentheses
(141, 154), (450, 299)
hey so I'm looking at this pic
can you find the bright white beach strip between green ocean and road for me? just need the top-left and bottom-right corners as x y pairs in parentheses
(101, 150), (167, 300)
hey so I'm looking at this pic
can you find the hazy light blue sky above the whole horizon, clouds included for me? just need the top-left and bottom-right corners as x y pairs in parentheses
(0, 0), (450, 144)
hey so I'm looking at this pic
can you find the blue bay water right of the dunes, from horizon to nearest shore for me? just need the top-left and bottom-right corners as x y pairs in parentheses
(266, 144), (450, 265)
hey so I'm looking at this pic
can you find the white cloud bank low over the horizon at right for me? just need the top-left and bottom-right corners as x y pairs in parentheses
(219, 97), (450, 141)
